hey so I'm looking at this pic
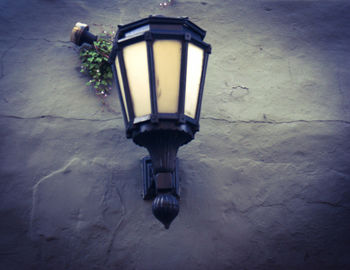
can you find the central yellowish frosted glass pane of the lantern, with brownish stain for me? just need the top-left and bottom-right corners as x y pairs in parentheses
(153, 40), (182, 113)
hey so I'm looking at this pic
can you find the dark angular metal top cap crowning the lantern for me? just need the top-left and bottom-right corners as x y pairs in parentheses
(118, 15), (206, 40)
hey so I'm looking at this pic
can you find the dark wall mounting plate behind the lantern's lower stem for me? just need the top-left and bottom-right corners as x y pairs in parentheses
(141, 156), (180, 200)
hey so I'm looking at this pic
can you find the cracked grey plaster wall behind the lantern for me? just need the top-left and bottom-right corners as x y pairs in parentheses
(0, 0), (350, 270)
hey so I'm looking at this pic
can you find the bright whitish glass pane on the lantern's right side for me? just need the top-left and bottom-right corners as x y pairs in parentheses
(185, 43), (204, 118)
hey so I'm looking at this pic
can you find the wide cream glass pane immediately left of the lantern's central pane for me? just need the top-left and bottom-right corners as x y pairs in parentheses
(123, 41), (151, 117)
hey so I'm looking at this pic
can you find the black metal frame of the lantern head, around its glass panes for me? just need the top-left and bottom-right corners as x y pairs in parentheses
(110, 16), (211, 138)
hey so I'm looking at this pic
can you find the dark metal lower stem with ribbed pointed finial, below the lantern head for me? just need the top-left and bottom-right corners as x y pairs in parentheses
(135, 121), (194, 229)
